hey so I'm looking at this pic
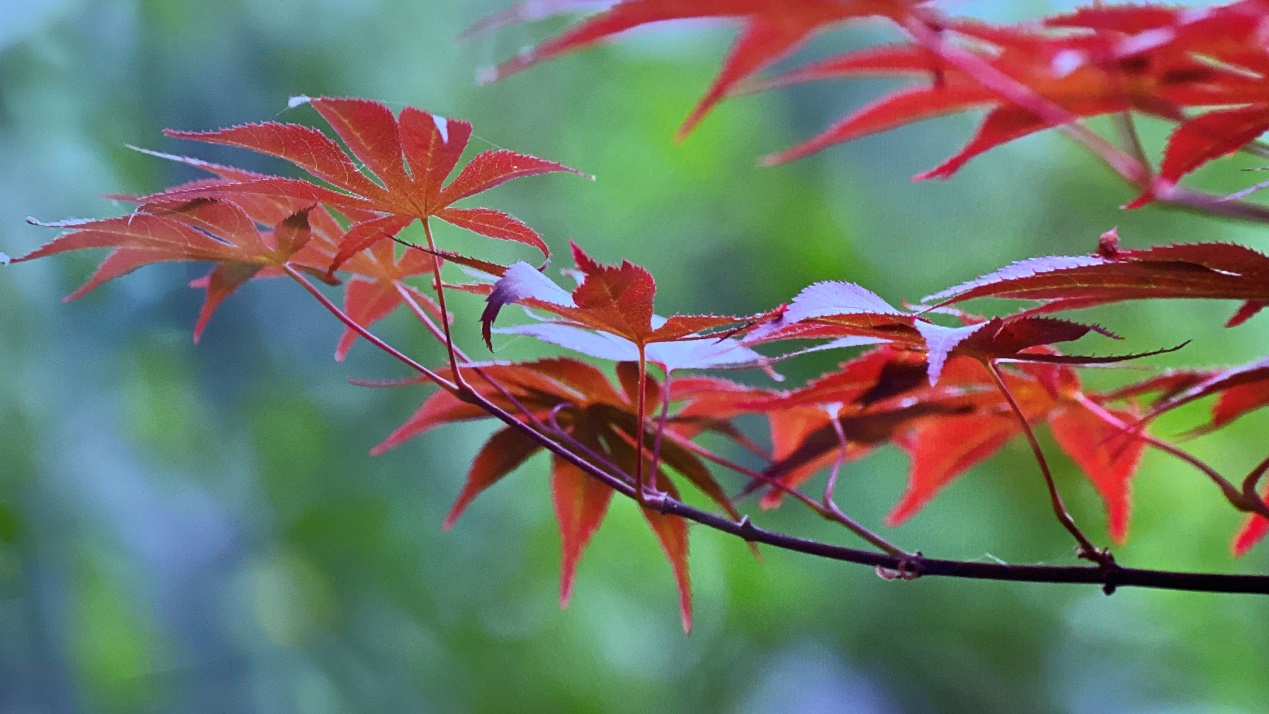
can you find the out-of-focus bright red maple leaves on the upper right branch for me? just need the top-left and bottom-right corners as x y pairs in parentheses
(472, 0), (1269, 207)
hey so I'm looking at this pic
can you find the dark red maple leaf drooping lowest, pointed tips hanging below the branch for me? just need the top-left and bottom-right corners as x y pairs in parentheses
(376, 359), (740, 626)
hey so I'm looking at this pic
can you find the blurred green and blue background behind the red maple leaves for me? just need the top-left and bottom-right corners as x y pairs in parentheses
(0, 0), (1269, 714)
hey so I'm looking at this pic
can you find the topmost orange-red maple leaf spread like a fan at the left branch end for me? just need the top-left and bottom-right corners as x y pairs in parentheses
(152, 98), (576, 270)
